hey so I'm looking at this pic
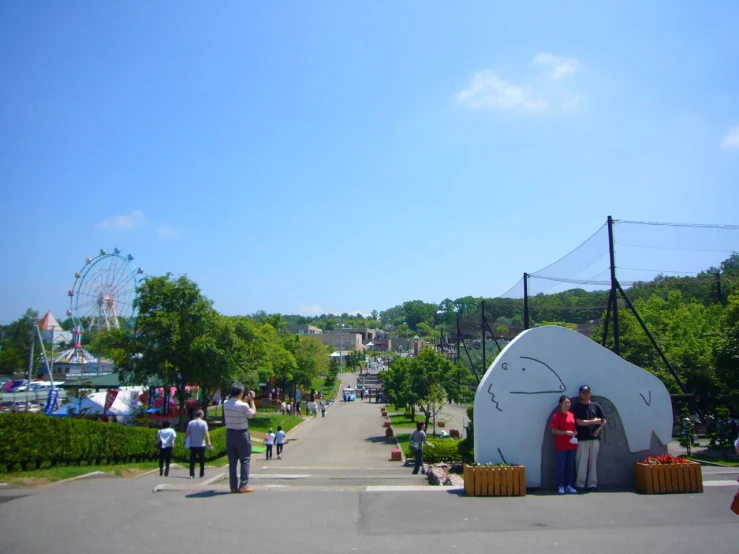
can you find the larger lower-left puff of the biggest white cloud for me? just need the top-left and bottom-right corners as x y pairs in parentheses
(457, 70), (549, 112)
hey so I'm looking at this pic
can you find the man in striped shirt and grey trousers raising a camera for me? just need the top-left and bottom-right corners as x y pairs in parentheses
(223, 383), (257, 493)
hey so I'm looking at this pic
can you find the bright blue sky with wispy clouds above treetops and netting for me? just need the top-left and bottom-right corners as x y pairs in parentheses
(0, 1), (739, 321)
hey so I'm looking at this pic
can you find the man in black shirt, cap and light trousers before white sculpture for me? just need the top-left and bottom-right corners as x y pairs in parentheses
(572, 385), (606, 492)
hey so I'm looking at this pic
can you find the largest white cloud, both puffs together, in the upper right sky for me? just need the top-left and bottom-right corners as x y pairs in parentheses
(456, 52), (580, 114)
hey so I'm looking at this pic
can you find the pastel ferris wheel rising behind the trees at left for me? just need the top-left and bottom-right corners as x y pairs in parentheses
(67, 248), (144, 331)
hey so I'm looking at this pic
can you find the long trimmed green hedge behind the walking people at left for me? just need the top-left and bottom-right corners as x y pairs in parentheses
(0, 413), (226, 471)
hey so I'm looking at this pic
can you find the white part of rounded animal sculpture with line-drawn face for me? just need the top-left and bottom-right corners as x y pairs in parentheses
(474, 325), (672, 487)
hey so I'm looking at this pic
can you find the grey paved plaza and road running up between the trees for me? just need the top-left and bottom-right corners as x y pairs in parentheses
(0, 370), (739, 554)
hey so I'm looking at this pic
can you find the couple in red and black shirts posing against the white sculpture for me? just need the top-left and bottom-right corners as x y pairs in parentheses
(550, 385), (607, 494)
